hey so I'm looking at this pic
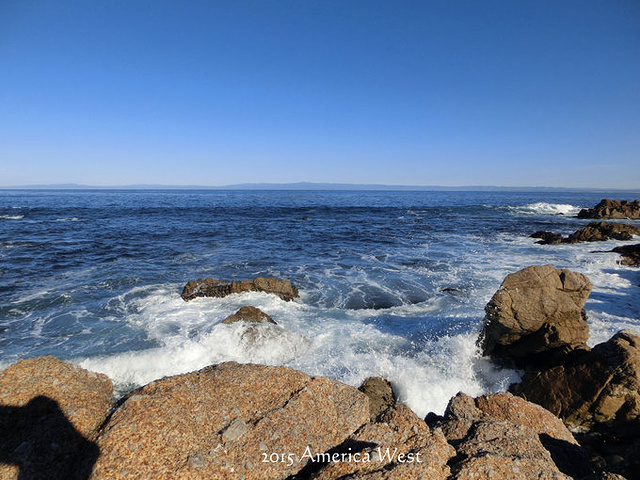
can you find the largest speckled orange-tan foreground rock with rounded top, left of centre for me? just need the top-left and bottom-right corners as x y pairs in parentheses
(91, 362), (369, 480)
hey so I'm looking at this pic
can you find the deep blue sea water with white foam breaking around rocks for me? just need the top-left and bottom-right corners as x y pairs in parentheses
(0, 190), (640, 415)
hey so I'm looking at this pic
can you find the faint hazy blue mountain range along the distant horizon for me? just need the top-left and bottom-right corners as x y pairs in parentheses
(0, 182), (640, 192)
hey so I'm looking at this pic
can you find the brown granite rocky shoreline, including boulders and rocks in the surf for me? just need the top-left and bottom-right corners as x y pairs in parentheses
(0, 198), (640, 480)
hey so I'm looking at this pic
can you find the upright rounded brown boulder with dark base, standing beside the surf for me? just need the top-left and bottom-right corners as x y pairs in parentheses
(479, 265), (591, 368)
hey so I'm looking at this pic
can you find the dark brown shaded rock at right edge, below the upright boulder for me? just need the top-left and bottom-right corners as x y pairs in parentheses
(510, 330), (640, 429)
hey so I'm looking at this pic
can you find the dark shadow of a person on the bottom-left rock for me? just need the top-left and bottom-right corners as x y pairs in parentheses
(0, 396), (100, 480)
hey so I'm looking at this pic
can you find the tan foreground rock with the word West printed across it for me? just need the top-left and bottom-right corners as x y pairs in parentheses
(304, 405), (455, 480)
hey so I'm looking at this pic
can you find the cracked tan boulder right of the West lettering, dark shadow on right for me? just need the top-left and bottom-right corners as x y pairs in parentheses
(433, 393), (591, 479)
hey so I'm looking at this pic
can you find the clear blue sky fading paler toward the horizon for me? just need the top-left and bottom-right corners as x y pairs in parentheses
(0, 0), (640, 189)
